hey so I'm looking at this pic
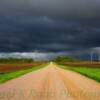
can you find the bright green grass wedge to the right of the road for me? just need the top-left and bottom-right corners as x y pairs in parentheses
(59, 65), (100, 82)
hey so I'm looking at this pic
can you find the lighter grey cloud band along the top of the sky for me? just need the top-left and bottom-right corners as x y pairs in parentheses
(0, 0), (100, 19)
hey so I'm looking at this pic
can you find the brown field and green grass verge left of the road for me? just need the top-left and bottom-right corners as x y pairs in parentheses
(0, 62), (47, 84)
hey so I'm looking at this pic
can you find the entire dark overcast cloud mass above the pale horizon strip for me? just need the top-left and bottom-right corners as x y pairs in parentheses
(0, 0), (100, 52)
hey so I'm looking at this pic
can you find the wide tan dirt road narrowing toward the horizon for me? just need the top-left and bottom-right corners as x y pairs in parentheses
(0, 63), (100, 100)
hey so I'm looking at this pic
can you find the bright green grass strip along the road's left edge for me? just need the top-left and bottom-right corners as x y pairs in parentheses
(0, 64), (47, 84)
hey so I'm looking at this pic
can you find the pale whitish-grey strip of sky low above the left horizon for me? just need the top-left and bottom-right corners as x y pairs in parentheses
(0, 52), (68, 60)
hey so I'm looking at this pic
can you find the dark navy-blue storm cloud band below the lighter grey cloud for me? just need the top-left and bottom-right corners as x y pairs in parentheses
(0, 16), (100, 52)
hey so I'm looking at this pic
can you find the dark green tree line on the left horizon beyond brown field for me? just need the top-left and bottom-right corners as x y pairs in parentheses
(0, 58), (34, 63)
